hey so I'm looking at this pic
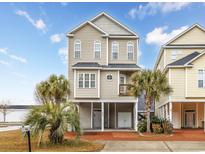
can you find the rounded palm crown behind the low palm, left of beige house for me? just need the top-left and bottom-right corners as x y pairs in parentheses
(35, 74), (70, 103)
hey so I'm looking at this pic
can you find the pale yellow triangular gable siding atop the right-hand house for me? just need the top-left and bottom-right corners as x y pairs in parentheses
(170, 27), (205, 45)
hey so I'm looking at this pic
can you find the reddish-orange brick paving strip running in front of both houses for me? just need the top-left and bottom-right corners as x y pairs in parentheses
(65, 129), (205, 141)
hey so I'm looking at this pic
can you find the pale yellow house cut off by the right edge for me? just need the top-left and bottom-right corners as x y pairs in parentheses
(154, 24), (205, 129)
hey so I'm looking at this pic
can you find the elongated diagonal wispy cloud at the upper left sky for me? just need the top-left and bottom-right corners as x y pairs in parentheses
(16, 10), (47, 33)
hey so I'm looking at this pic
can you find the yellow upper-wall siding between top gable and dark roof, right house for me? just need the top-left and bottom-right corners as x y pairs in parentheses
(164, 48), (205, 65)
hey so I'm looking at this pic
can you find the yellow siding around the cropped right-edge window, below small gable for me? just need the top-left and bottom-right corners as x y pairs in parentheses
(187, 55), (205, 98)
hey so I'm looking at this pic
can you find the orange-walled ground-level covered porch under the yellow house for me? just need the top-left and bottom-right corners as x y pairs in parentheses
(160, 102), (205, 129)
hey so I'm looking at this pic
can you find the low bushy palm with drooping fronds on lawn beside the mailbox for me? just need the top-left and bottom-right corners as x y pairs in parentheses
(25, 102), (80, 146)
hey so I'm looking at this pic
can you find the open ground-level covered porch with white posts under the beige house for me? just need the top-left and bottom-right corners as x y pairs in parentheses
(79, 102), (137, 132)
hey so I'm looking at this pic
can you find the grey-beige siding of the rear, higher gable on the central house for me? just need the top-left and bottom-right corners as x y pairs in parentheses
(93, 16), (131, 35)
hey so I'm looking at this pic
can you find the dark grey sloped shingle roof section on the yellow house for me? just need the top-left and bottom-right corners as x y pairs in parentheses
(167, 52), (200, 66)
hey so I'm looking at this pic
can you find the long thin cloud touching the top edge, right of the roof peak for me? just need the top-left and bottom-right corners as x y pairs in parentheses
(128, 2), (190, 19)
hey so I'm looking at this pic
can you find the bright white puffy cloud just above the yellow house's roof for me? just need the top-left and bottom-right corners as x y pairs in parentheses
(145, 26), (188, 46)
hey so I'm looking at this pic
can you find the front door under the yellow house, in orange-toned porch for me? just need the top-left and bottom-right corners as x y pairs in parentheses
(185, 111), (195, 128)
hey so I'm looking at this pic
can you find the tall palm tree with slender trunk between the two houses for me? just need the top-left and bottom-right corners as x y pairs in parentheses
(130, 70), (172, 132)
